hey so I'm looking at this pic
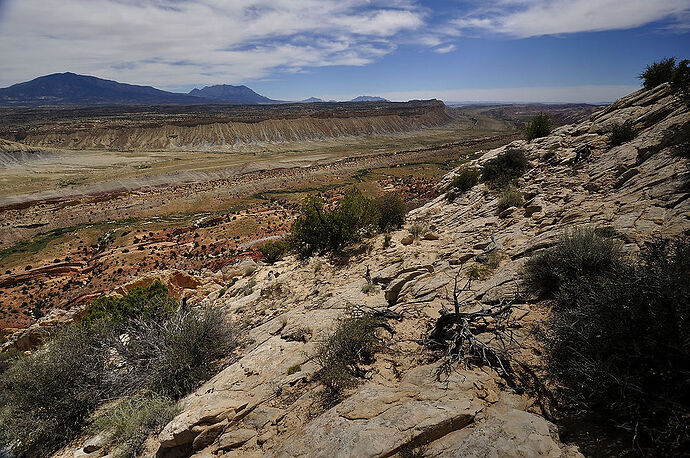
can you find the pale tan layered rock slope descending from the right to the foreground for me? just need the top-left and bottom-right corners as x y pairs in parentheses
(55, 86), (690, 457)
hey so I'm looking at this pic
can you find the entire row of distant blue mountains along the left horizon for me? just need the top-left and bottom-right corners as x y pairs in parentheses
(0, 72), (387, 106)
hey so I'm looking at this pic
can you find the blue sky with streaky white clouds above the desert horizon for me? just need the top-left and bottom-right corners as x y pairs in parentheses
(0, 0), (690, 102)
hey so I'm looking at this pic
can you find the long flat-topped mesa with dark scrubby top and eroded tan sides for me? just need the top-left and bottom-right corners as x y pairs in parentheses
(0, 100), (453, 151)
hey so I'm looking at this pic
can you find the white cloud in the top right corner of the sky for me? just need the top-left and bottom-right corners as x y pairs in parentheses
(452, 0), (690, 38)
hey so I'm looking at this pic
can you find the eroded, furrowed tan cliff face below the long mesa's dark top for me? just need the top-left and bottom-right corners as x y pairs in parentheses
(17, 103), (452, 150)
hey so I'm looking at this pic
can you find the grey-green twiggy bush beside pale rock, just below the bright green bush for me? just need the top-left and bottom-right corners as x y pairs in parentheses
(113, 307), (237, 399)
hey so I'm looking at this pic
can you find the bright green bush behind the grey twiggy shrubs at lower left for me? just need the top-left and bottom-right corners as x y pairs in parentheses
(81, 280), (178, 326)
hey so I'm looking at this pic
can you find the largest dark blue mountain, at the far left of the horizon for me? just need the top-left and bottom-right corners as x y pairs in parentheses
(0, 72), (207, 105)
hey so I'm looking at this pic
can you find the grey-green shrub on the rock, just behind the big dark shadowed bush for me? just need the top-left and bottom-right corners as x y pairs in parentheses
(525, 229), (622, 292)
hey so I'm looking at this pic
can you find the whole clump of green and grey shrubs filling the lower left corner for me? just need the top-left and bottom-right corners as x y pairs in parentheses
(0, 286), (236, 457)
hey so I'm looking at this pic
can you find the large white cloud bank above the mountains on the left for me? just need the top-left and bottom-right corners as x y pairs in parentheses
(0, 0), (424, 87)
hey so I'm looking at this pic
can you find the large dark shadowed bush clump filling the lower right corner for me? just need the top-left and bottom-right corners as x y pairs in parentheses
(527, 233), (690, 456)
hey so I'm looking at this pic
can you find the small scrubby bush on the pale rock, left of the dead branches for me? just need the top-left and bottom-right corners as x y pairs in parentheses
(315, 314), (381, 394)
